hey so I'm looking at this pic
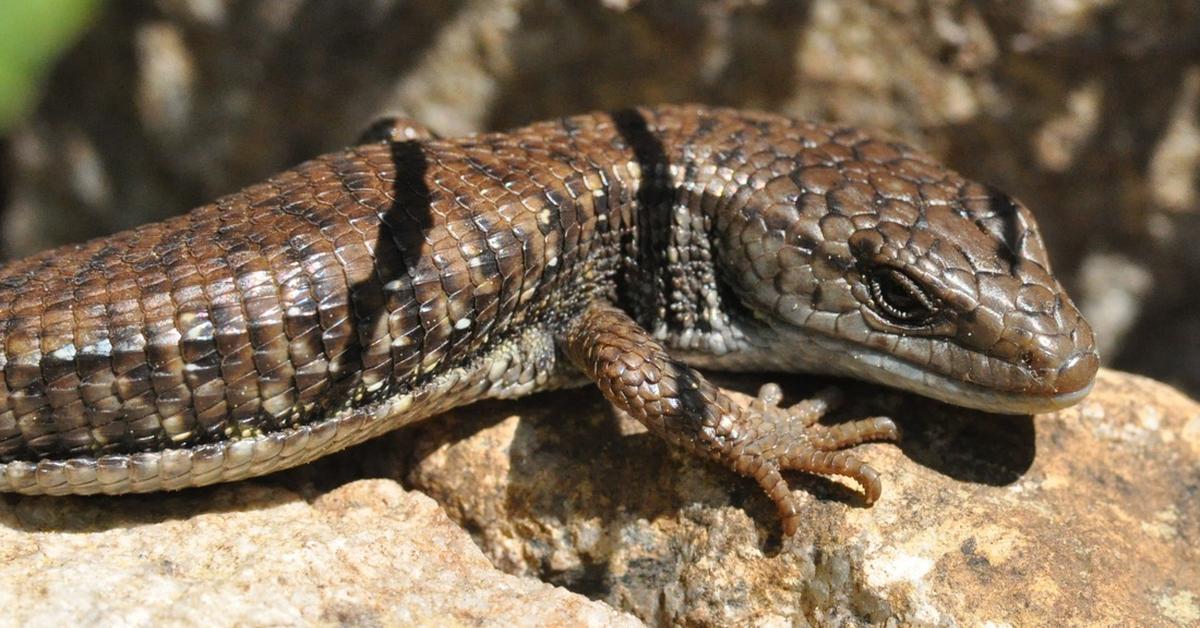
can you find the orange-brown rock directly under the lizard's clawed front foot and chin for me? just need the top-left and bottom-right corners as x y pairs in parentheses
(409, 371), (1200, 626)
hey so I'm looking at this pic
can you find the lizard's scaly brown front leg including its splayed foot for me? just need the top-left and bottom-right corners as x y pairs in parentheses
(560, 303), (899, 536)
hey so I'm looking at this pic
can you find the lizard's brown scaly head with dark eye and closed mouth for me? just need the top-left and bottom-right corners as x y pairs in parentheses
(715, 120), (1099, 413)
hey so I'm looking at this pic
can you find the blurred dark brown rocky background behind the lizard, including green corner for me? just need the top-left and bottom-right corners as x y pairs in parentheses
(0, 0), (1200, 396)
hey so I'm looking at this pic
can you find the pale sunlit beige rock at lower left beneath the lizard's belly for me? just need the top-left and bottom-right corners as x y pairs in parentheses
(0, 479), (638, 626)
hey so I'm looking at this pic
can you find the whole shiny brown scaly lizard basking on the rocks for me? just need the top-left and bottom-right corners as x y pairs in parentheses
(0, 106), (1098, 533)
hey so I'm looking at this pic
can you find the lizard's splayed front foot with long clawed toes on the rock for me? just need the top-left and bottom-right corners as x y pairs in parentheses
(728, 384), (900, 536)
